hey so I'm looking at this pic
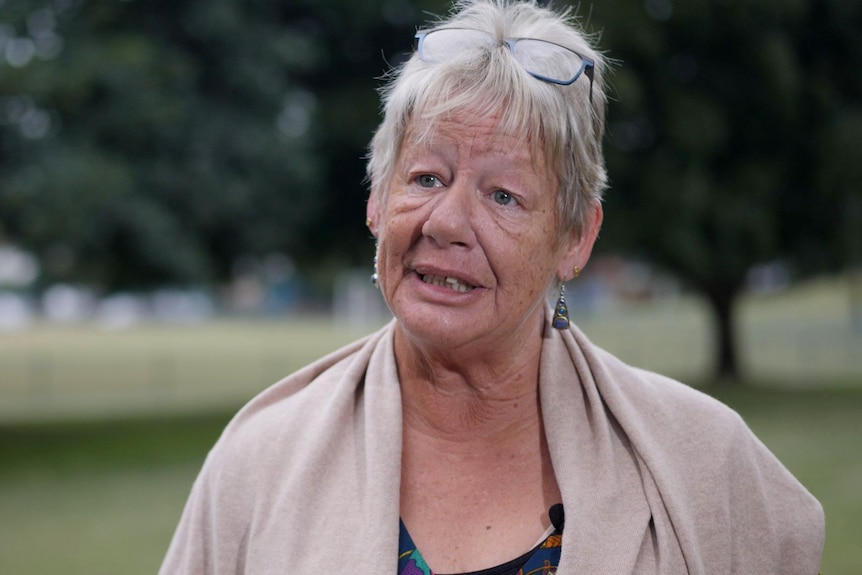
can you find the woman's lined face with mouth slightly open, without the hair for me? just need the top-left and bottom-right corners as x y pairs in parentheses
(368, 114), (592, 356)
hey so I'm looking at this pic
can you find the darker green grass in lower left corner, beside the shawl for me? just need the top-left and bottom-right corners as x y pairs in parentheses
(0, 413), (233, 575)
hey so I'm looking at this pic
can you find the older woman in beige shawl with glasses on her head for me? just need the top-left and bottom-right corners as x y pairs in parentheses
(162, 0), (824, 575)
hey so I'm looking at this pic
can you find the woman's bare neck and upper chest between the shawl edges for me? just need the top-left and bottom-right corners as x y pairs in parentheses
(395, 320), (561, 572)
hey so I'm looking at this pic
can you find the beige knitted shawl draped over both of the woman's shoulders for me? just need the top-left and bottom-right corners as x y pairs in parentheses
(161, 323), (824, 575)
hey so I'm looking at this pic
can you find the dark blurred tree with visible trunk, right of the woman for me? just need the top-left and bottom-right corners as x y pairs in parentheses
(590, 0), (862, 381)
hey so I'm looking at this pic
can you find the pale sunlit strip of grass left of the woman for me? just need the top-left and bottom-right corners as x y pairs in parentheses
(0, 318), (380, 421)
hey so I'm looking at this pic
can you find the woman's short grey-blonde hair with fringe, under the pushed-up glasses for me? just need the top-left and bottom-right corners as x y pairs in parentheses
(367, 0), (607, 239)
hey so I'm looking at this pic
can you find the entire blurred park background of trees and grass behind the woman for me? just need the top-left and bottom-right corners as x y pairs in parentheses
(0, 0), (862, 574)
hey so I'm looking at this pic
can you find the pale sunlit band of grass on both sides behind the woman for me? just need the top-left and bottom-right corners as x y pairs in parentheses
(0, 280), (862, 421)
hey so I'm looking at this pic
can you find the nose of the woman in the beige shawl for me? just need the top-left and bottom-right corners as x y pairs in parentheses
(422, 181), (475, 247)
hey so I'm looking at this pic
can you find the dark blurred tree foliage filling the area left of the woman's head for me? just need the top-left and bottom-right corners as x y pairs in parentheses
(0, 0), (452, 290)
